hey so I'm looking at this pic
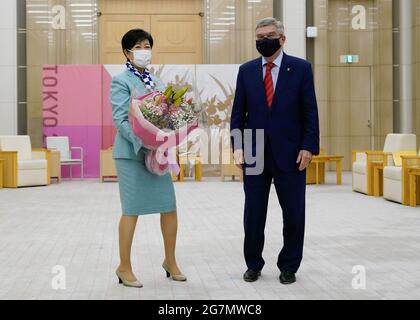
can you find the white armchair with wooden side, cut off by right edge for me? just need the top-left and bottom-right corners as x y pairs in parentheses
(384, 151), (420, 205)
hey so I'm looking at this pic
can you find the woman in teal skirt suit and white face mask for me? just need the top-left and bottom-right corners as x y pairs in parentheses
(110, 29), (187, 288)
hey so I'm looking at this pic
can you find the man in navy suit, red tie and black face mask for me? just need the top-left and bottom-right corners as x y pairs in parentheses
(231, 18), (319, 284)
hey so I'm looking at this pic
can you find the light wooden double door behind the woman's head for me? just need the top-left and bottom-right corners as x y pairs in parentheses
(99, 0), (203, 64)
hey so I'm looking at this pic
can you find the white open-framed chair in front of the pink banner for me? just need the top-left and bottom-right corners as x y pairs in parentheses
(47, 137), (84, 180)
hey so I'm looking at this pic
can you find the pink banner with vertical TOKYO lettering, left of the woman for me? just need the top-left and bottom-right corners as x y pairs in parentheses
(42, 65), (107, 178)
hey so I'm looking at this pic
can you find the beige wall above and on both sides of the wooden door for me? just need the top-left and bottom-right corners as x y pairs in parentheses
(27, 0), (273, 147)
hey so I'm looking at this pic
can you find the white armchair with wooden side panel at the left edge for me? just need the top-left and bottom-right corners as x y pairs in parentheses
(0, 136), (49, 188)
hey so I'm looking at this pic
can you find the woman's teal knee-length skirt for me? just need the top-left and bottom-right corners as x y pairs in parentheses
(115, 159), (176, 216)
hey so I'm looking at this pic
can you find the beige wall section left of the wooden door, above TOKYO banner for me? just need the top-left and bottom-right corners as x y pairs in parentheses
(26, 0), (98, 147)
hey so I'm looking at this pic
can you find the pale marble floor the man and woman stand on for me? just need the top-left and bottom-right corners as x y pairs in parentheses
(0, 173), (420, 300)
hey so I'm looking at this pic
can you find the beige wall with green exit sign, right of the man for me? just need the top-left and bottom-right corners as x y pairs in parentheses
(314, 0), (393, 170)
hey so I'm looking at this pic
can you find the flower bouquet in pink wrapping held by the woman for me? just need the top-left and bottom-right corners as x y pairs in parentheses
(130, 86), (201, 175)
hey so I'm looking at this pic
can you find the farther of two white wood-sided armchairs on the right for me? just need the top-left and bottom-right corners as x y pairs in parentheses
(353, 134), (417, 195)
